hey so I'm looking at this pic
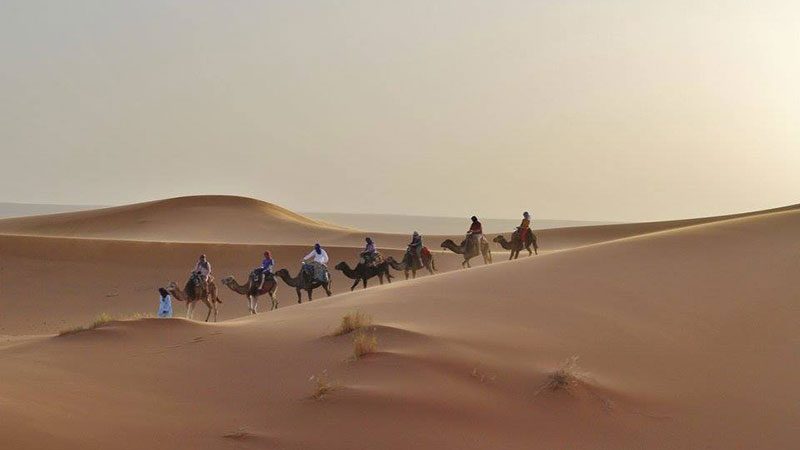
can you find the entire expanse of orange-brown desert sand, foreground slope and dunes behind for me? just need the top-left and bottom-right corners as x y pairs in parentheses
(0, 197), (800, 449)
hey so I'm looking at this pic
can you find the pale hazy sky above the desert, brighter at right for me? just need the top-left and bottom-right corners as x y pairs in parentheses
(0, 0), (800, 220)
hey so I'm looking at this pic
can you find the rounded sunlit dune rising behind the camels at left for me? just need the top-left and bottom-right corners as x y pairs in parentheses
(0, 195), (353, 244)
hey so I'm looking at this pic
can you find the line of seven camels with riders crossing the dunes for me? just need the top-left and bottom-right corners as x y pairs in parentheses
(159, 212), (539, 322)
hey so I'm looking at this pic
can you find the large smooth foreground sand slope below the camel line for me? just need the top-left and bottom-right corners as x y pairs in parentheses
(0, 205), (800, 449)
